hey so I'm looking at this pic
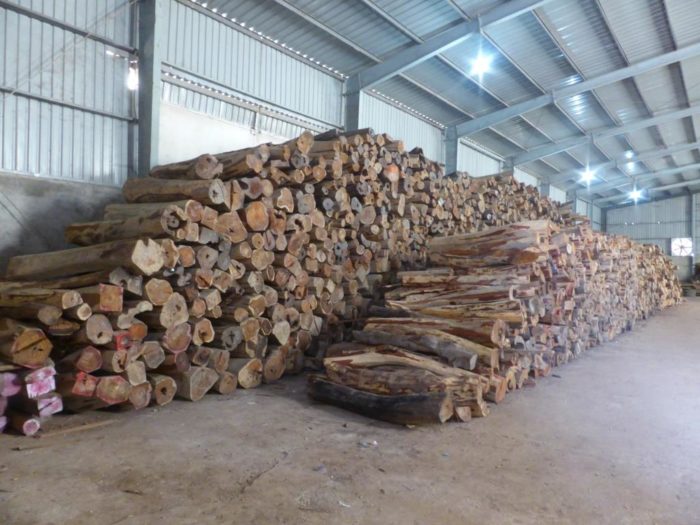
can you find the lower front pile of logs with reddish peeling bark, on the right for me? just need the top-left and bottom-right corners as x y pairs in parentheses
(310, 220), (681, 424)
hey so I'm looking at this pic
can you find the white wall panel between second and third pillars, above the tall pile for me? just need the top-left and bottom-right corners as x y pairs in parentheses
(359, 93), (444, 162)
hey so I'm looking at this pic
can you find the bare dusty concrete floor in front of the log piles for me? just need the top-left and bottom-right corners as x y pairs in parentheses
(0, 300), (700, 525)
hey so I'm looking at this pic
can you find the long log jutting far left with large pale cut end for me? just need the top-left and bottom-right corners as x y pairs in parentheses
(6, 237), (163, 278)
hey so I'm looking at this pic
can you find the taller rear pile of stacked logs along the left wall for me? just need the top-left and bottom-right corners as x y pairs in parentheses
(0, 130), (673, 428)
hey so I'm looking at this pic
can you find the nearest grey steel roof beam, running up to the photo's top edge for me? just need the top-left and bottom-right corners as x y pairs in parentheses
(348, 0), (550, 91)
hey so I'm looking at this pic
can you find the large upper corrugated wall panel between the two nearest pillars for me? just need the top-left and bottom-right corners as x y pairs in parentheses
(162, 0), (343, 126)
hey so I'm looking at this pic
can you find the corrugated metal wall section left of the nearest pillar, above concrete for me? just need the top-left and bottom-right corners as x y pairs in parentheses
(0, 0), (134, 185)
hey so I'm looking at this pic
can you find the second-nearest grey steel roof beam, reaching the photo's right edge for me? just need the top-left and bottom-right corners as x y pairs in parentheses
(457, 42), (700, 137)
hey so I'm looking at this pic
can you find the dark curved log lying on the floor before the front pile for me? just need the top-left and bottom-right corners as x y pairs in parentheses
(308, 376), (454, 425)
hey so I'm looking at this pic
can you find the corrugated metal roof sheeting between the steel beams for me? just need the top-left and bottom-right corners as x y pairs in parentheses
(168, 0), (700, 205)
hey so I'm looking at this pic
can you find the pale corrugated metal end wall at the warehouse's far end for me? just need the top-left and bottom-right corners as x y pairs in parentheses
(606, 196), (693, 279)
